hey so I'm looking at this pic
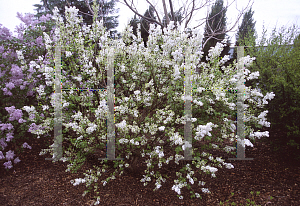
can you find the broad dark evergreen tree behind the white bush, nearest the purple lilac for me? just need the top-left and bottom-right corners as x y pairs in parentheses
(33, 0), (119, 37)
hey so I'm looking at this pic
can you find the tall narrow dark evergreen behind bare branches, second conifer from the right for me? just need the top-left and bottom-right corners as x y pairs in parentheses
(201, 0), (230, 71)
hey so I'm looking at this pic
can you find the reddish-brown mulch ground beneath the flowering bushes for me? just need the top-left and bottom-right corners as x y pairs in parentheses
(0, 127), (300, 206)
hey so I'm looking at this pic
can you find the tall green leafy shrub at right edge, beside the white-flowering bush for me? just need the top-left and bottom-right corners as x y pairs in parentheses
(241, 24), (300, 156)
